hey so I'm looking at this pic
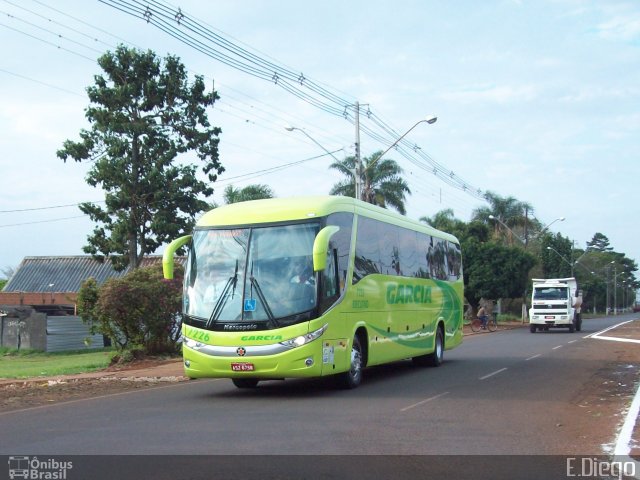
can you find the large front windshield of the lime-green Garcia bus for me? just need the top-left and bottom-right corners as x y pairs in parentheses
(184, 223), (319, 330)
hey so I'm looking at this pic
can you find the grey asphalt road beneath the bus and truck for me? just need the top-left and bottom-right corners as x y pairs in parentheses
(0, 316), (637, 478)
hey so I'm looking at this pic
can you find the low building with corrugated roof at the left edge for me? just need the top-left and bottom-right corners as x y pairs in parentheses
(0, 255), (183, 352)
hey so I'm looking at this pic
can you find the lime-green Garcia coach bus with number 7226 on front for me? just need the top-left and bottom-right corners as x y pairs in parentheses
(163, 196), (464, 388)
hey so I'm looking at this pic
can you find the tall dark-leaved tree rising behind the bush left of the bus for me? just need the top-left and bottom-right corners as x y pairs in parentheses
(57, 45), (224, 269)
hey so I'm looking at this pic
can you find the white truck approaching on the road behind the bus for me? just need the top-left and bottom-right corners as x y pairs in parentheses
(529, 277), (582, 333)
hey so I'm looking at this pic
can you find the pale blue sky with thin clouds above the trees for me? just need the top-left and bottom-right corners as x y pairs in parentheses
(0, 0), (640, 277)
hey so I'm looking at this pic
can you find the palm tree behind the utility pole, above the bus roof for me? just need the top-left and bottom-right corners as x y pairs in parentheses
(329, 151), (411, 215)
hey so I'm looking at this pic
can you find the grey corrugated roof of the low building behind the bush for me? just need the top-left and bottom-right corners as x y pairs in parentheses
(2, 255), (184, 293)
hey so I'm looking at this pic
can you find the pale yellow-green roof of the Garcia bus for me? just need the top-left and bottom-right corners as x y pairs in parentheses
(196, 195), (458, 243)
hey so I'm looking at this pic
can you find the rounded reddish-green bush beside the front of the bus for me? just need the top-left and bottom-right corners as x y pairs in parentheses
(78, 265), (183, 358)
